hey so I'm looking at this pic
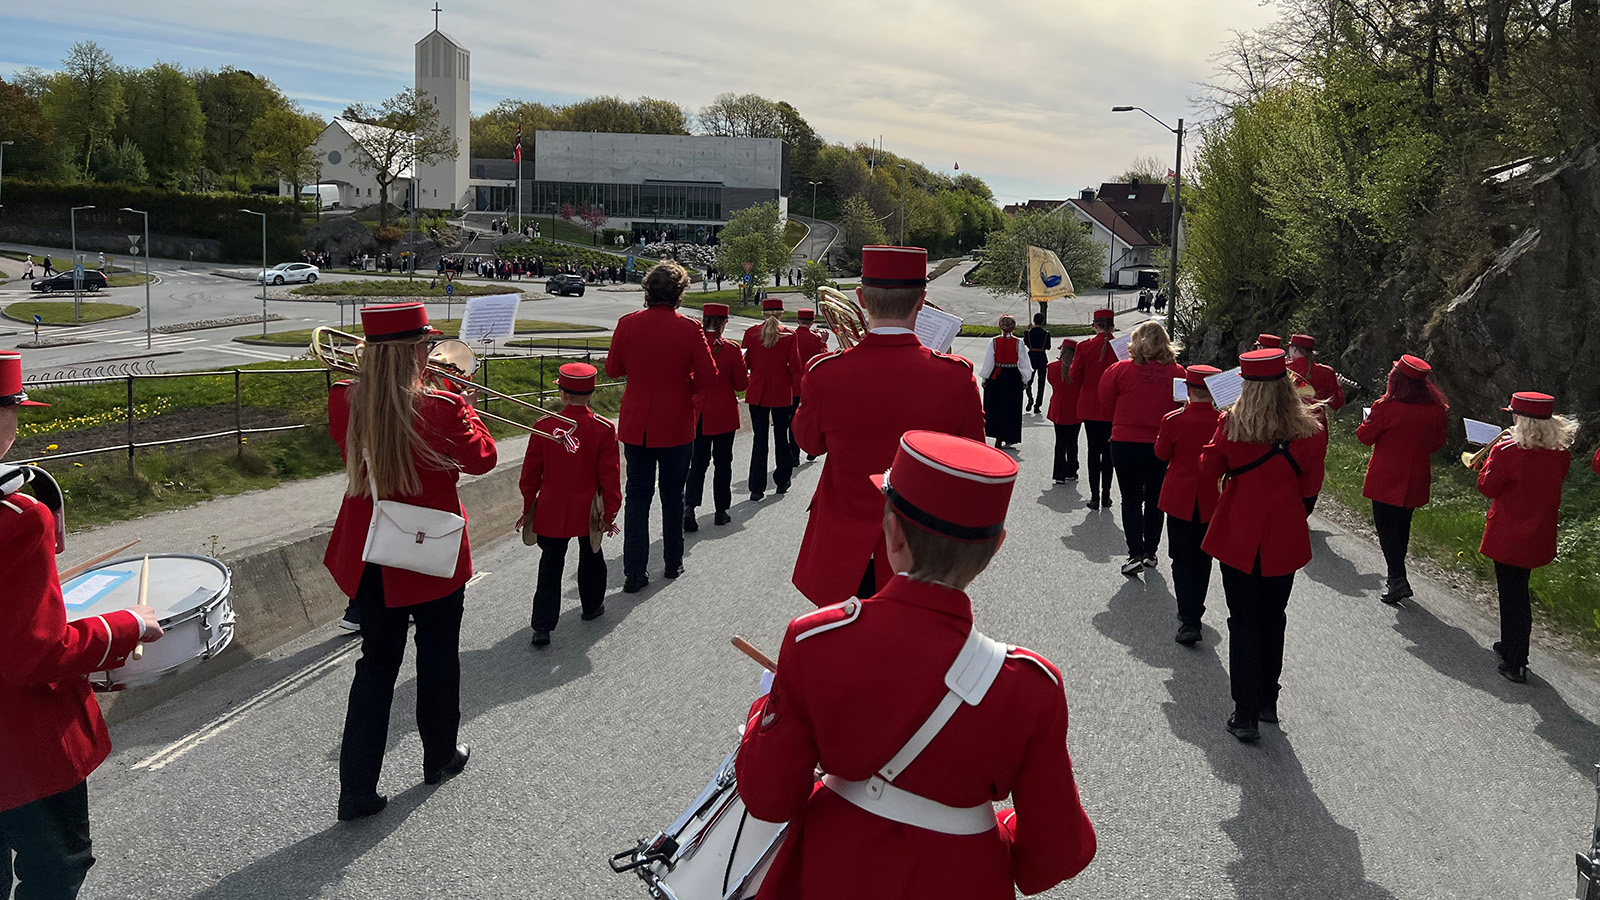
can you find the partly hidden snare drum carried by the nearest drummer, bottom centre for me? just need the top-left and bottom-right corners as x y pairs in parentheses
(611, 749), (789, 900)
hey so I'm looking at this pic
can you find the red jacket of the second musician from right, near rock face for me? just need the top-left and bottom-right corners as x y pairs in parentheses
(1355, 399), (1445, 509)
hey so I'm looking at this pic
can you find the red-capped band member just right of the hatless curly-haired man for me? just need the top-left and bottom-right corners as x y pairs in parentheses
(683, 303), (750, 532)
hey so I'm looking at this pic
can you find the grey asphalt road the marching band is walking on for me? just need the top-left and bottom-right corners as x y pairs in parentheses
(72, 408), (1600, 900)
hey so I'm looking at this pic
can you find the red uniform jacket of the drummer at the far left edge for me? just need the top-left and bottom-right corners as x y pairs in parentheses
(0, 493), (142, 810)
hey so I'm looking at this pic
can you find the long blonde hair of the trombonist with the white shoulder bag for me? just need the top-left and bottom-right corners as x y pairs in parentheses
(344, 341), (451, 498)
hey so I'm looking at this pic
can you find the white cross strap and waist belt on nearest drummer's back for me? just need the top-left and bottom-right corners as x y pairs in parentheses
(822, 628), (1006, 834)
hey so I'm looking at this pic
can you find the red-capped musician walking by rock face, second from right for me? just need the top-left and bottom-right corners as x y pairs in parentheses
(1355, 354), (1450, 605)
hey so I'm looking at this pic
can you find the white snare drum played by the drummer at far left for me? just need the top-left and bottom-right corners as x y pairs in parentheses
(61, 552), (234, 690)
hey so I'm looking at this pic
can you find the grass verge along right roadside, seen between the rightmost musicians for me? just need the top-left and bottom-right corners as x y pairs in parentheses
(1325, 410), (1600, 647)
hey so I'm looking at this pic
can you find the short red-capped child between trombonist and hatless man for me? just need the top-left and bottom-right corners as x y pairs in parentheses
(517, 362), (622, 647)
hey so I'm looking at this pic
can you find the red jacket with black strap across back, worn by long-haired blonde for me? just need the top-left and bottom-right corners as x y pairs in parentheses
(1200, 415), (1315, 577)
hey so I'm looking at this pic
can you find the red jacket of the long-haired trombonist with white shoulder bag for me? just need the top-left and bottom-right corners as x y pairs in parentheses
(322, 381), (498, 607)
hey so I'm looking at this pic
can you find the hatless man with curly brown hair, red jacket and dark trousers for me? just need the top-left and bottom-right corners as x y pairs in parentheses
(605, 261), (717, 594)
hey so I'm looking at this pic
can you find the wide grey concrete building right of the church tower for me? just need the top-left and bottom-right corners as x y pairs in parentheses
(470, 131), (789, 243)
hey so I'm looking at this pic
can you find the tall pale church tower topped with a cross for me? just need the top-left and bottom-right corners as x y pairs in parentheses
(416, 24), (472, 211)
